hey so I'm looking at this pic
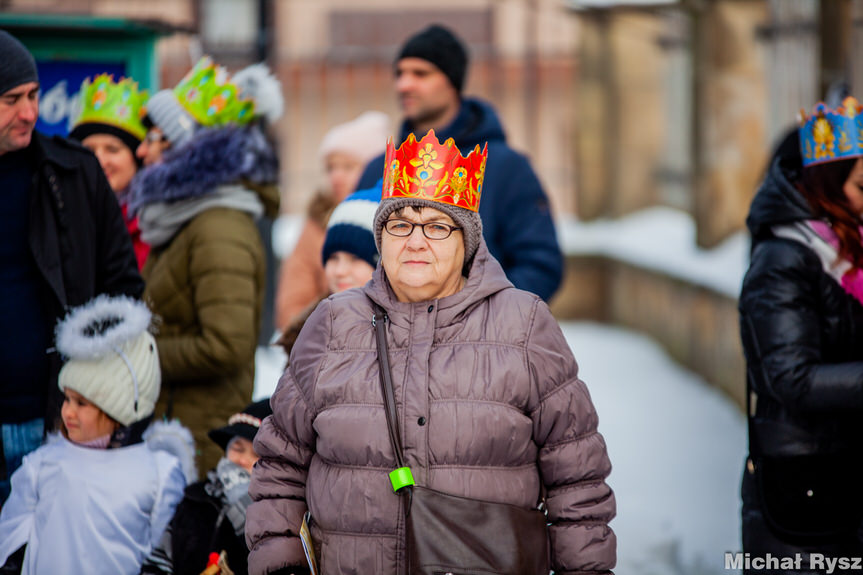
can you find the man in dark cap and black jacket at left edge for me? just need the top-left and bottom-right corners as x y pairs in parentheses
(0, 30), (144, 505)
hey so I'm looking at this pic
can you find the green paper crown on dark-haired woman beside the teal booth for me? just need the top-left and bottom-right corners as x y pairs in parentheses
(75, 74), (147, 140)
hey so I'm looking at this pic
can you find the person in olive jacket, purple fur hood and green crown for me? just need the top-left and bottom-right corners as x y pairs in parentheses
(130, 58), (281, 469)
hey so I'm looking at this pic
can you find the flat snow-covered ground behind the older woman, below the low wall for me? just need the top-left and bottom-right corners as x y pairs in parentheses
(255, 322), (746, 575)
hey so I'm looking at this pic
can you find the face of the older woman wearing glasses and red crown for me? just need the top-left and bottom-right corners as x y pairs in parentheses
(381, 207), (464, 302)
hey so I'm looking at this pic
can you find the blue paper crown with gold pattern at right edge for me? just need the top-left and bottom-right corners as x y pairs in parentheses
(800, 96), (863, 166)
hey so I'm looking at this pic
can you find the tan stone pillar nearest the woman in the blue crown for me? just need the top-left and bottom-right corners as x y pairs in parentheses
(693, 0), (770, 247)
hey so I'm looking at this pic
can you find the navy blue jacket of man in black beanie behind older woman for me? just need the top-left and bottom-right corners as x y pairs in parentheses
(357, 98), (563, 300)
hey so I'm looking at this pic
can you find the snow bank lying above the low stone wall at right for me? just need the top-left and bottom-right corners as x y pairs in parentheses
(556, 207), (749, 298)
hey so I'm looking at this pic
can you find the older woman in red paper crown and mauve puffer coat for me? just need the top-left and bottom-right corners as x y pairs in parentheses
(246, 132), (616, 575)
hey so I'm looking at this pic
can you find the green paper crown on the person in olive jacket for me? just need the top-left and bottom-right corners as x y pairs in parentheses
(174, 56), (255, 127)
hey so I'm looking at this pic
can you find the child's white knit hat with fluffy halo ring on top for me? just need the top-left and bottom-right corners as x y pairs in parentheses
(57, 295), (162, 426)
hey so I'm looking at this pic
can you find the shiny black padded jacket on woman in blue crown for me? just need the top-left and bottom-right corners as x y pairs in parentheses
(739, 132), (863, 456)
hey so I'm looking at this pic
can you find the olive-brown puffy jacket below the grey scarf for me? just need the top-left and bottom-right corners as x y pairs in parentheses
(142, 183), (278, 472)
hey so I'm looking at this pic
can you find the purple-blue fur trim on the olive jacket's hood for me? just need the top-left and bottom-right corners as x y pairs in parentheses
(129, 125), (279, 213)
